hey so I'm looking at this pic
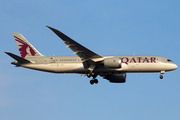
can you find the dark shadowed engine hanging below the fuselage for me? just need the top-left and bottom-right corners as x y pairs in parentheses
(104, 73), (126, 83)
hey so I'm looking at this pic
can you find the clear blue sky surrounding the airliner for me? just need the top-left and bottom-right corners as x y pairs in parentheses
(0, 0), (180, 120)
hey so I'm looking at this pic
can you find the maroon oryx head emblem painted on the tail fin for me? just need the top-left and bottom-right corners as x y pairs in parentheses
(14, 36), (36, 58)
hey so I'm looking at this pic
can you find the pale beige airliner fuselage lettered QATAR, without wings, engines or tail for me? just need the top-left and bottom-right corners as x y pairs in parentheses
(22, 55), (177, 74)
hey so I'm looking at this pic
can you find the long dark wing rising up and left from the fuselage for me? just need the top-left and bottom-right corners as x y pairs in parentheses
(45, 25), (103, 62)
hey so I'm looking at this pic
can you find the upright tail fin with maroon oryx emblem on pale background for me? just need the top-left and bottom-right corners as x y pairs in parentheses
(13, 33), (43, 58)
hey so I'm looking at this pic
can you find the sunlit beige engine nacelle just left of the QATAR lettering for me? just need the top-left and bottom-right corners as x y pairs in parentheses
(104, 57), (122, 68)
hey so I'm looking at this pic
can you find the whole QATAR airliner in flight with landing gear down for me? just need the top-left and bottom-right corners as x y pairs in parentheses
(5, 25), (177, 85)
